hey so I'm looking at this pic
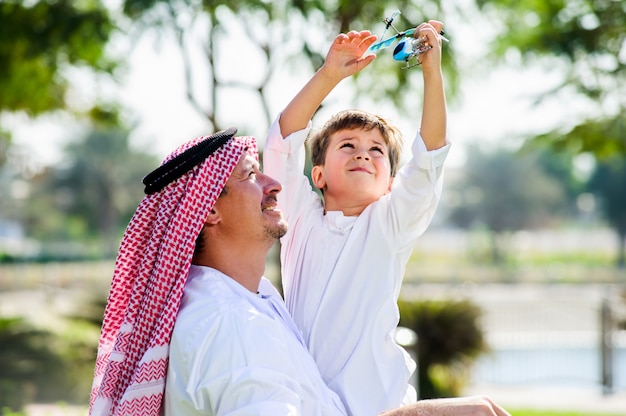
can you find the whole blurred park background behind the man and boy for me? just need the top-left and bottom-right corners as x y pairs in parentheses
(0, 0), (626, 416)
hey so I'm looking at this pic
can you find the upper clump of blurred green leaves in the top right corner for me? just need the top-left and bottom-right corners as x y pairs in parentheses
(476, 0), (626, 88)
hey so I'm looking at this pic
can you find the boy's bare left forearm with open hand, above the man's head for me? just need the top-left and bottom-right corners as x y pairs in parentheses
(279, 30), (376, 137)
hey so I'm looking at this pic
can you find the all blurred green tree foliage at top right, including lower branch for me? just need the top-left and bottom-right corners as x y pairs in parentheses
(476, 0), (626, 156)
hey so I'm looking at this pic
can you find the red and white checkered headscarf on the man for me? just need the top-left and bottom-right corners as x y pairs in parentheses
(89, 133), (258, 416)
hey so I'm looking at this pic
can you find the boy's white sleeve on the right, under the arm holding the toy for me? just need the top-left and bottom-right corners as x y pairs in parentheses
(386, 133), (450, 249)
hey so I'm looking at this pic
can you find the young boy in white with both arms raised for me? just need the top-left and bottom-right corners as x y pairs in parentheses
(263, 21), (449, 415)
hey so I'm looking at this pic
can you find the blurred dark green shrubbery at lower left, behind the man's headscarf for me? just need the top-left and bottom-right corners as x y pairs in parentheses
(0, 297), (106, 414)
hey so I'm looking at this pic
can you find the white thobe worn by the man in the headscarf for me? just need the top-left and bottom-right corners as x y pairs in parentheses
(165, 266), (345, 416)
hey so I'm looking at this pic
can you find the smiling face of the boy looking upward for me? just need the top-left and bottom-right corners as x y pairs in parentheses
(312, 129), (391, 211)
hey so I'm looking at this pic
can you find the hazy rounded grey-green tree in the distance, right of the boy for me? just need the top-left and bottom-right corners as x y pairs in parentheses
(449, 146), (567, 263)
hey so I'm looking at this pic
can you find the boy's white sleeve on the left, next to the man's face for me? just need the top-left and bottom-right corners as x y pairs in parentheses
(263, 115), (321, 223)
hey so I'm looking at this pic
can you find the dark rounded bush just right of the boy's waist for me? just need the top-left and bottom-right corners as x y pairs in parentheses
(398, 299), (488, 398)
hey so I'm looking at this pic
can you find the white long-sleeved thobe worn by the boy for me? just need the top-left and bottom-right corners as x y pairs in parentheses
(263, 121), (449, 416)
